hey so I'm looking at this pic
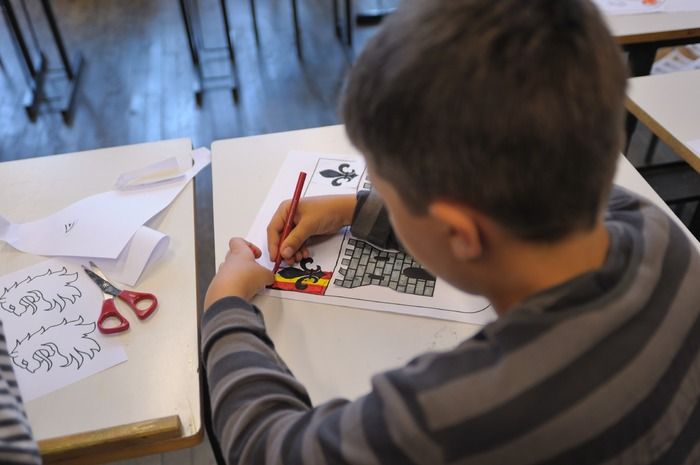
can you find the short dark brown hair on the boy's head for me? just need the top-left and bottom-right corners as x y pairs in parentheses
(342, 0), (627, 241)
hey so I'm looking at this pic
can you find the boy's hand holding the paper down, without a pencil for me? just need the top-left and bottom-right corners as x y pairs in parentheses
(204, 237), (274, 310)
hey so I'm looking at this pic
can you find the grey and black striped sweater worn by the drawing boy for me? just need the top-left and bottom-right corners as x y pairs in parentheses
(202, 188), (700, 465)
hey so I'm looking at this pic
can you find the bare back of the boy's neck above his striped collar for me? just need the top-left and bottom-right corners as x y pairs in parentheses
(486, 221), (610, 316)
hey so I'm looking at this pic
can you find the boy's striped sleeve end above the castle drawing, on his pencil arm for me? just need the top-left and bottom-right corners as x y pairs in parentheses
(350, 189), (399, 249)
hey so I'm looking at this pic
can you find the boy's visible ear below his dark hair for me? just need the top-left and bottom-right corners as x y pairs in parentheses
(428, 200), (485, 260)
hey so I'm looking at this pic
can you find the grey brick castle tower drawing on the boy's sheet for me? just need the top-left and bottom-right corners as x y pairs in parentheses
(333, 239), (435, 297)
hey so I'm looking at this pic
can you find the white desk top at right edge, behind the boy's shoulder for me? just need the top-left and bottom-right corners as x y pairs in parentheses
(627, 70), (700, 172)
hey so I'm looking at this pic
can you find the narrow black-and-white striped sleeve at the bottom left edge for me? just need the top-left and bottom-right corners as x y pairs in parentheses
(0, 322), (41, 465)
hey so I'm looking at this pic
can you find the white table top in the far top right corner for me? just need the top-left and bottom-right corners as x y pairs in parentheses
(605, 11), (700, 45)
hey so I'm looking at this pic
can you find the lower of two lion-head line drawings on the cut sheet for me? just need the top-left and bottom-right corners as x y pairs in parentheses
(10, 316), (101, 373)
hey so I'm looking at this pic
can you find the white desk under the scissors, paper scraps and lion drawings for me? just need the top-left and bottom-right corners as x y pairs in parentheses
(0, 139), (203, 463)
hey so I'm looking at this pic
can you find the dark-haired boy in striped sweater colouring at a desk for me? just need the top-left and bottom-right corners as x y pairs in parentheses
(202, 0), (700, 465)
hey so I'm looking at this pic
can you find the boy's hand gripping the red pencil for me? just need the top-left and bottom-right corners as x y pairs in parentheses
(267, 194), (357, 265)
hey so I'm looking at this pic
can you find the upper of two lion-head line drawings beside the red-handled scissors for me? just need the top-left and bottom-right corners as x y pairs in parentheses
(0, 266), (82, 316)
